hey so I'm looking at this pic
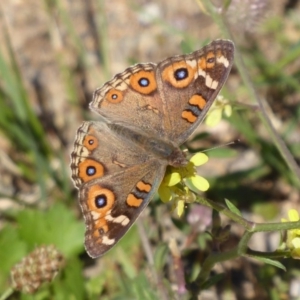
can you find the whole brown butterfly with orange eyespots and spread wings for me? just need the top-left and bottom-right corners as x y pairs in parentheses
(71, 40), (234, 257)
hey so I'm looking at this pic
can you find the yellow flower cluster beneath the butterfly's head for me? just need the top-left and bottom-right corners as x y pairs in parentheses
(158, 153), (209, 217)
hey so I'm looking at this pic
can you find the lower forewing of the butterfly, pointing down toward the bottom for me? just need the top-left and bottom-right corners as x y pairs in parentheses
(80, 161), (165, 257)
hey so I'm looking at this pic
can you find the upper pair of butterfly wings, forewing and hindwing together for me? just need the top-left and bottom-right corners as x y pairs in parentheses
(90, 40), (234, 146)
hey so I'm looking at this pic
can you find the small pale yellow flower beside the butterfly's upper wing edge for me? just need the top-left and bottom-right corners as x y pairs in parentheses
(205, 96), (232, 127)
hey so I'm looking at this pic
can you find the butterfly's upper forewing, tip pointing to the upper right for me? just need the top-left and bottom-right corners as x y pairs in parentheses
(156, 40), (234, 145)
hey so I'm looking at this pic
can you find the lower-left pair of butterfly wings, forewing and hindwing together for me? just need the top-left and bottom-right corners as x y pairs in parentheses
(71, 122), (167, 257)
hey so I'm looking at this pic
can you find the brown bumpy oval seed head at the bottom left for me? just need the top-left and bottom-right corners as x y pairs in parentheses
(11, 245), (64, 294)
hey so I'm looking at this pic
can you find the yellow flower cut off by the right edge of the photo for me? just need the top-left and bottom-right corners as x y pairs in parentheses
(281, 209), (300, 259)
